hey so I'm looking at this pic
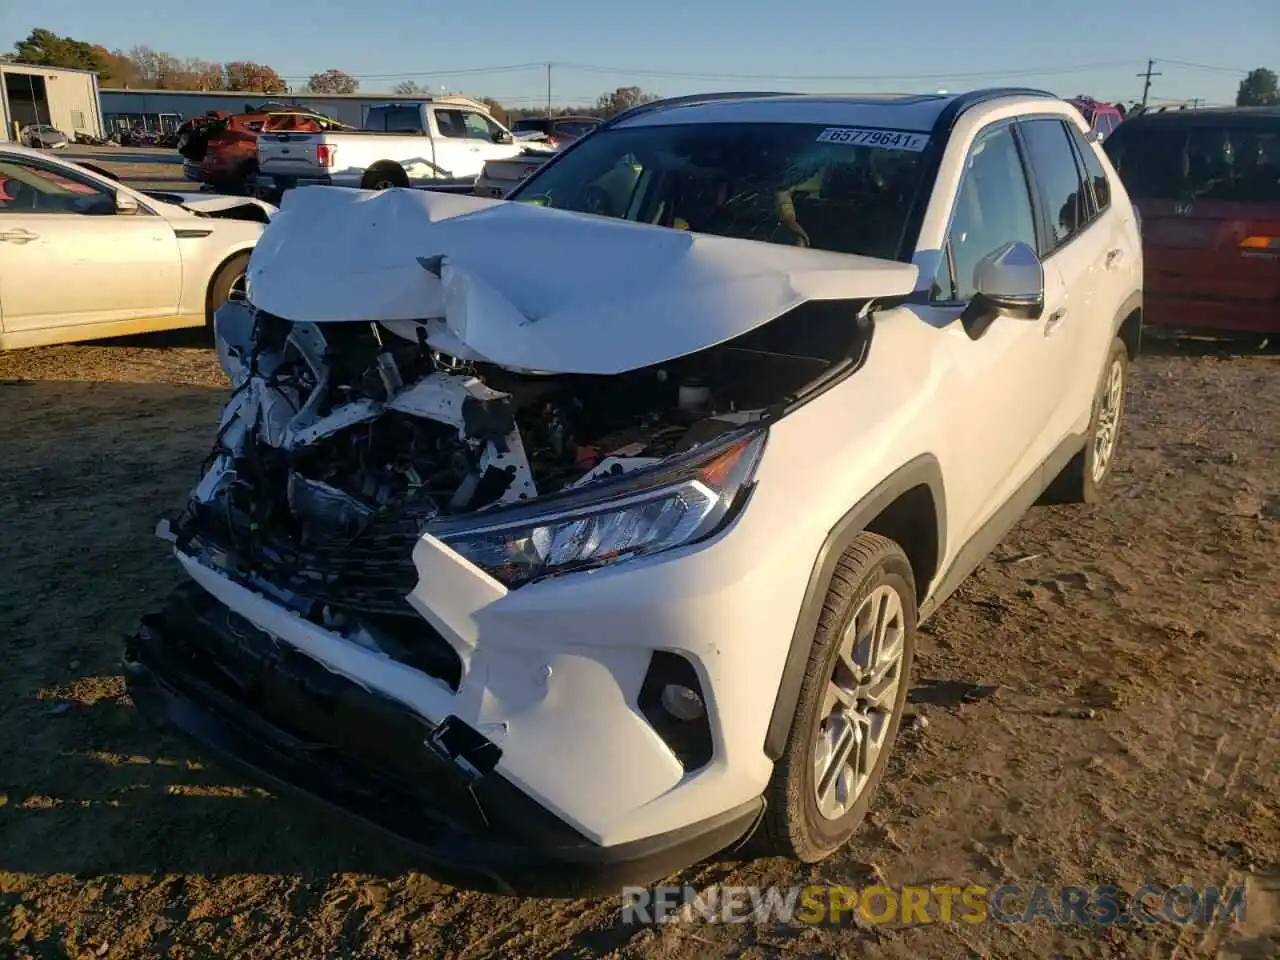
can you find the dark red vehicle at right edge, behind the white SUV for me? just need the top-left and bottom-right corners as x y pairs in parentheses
(1105, 106), (1280, 333)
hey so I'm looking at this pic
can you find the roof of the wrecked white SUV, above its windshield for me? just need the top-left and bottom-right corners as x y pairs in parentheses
(617, 88), (1060, 132)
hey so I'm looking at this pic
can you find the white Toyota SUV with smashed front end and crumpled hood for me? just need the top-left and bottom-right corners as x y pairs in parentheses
(125, 90), (1142, 893)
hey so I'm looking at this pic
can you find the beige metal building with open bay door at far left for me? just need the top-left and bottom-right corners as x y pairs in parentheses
(0, 63), (102, 141)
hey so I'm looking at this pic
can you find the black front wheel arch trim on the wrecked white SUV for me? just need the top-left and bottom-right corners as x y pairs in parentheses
(764, 453), (947, 760)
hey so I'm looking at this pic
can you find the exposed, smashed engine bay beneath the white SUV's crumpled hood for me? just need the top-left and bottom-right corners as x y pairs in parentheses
(169, 301), (870, 650)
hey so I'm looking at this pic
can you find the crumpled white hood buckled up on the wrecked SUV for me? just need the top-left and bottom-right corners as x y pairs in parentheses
(241, 187), (916, 374)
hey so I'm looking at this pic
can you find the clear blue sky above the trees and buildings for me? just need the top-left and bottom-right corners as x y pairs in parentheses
(0, 0), (1280, 105)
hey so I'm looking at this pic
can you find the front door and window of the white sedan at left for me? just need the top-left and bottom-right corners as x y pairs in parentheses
(0, 154), (182, 334)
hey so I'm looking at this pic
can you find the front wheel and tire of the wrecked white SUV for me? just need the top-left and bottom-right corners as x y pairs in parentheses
(762, 532), (916, 863)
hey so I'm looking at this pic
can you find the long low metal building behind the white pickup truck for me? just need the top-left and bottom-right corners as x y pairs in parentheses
(102, 90), (450, 133)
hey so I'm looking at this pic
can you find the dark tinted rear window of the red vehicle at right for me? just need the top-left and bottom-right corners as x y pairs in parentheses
(1103, 122), (1280, 204)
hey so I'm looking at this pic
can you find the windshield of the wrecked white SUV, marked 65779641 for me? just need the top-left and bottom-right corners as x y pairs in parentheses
(511, 123), (928, 259)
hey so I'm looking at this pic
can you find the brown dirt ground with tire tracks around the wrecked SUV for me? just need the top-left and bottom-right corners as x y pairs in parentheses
(0, 334), (1280, 960)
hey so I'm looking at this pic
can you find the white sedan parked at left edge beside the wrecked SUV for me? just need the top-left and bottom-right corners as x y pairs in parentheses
(0, 143), (275, 349)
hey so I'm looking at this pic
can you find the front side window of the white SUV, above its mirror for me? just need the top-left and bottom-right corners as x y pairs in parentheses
(933, 124), (1036, 301)
